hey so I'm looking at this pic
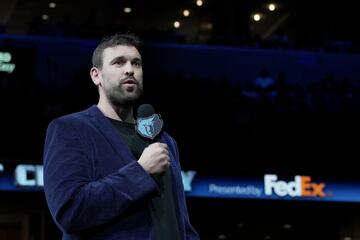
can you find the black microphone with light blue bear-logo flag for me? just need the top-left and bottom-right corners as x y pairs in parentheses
(135, 104), (164, 143)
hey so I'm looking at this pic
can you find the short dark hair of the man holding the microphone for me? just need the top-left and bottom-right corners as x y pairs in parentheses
(91, 33), (143, 68)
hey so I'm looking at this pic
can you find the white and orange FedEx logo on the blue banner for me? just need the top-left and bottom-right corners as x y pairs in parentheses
(264, 174), (326, 197)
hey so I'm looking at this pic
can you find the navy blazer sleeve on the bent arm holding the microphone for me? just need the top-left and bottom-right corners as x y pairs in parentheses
(44, 120), (158, 233)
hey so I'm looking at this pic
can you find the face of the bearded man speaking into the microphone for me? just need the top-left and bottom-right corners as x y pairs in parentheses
(99, 45), (143, 106)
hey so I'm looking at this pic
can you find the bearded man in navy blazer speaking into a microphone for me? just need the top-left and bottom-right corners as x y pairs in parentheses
(44, 34), (199, 240)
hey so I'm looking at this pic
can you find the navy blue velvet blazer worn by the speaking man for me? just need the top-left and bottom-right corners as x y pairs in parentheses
(44, 105), (199, 240)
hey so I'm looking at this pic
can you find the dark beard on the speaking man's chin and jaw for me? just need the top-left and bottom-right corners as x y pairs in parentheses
(107, 85), (143, 107)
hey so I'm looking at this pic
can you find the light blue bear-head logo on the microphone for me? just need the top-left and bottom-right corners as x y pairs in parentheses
(136, 114), (163, 139)
